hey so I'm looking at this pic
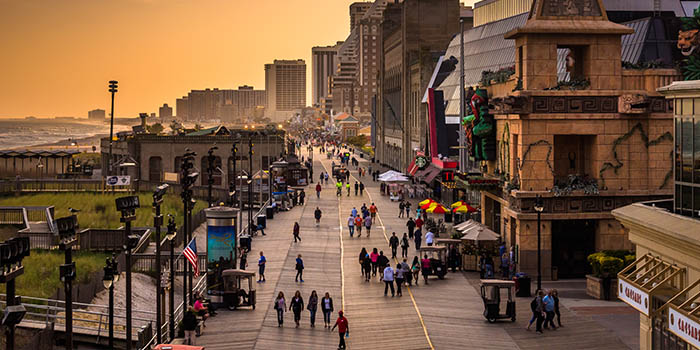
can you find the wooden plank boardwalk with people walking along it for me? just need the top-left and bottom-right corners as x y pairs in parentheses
(197, 146), (636, 349)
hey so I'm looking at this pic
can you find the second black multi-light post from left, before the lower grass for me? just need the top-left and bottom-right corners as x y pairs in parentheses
(56, 215), (78, 350)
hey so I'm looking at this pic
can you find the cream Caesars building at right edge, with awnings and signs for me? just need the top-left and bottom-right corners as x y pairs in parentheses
(612, 80), (700, 350)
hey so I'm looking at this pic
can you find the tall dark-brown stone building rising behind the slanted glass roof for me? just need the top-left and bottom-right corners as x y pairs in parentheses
(375, 0), (460, 170)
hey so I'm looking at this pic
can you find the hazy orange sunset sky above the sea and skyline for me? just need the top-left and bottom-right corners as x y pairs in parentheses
(0, 0), (472, 117)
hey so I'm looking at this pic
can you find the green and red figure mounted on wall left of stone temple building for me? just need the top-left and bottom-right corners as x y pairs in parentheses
(462, 88), (496, 161)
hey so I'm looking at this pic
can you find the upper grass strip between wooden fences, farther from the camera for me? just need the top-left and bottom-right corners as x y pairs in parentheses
(0, 192), (207, 228)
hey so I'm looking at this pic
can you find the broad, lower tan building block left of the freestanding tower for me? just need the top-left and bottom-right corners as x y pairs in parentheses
(176, 85), (266, 122)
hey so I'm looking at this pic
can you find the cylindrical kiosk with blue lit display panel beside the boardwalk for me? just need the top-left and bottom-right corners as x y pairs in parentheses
(204, 207), (241, 305)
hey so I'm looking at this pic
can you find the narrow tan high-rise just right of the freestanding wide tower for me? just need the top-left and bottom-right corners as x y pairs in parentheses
(311, 41), (343, 105)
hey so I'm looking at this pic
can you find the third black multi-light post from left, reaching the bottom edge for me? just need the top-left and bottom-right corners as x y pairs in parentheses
(115, 196), (141, 350)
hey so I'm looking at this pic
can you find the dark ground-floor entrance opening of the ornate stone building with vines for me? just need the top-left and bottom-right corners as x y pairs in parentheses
(552, 220), (596, 278)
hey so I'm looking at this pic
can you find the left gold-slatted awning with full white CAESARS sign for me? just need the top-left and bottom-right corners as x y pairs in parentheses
(617, 254), (685, 316)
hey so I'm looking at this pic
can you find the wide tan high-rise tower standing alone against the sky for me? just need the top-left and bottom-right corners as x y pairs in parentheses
(265, 59), (306, 119)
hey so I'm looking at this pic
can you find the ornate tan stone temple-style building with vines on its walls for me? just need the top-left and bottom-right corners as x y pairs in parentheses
(482, 0), (678, 278)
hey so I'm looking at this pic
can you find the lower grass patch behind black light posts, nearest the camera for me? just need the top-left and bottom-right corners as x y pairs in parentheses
(0, 250), (108, 298)
